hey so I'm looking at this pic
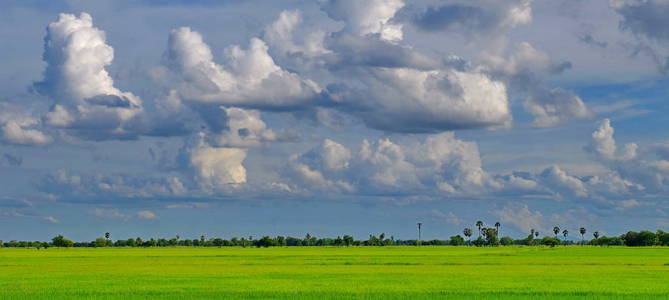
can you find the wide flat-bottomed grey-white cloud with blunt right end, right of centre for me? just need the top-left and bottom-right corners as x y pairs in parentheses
(328, 68), (512, 132)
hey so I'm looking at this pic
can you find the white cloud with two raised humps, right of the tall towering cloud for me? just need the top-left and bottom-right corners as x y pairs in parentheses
(166, 27), (320, 110)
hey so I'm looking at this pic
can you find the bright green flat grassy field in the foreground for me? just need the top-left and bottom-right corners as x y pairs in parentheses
(0, 247), (669, 299)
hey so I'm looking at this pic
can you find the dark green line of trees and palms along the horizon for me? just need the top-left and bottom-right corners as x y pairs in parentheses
(0, 221), (669, 249)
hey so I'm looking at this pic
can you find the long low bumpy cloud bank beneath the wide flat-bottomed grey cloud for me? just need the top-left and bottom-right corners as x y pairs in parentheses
(290, 133), (501, 195)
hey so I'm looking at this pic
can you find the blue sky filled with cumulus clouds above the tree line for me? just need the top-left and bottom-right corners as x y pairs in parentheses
(0, 0), (669, 241)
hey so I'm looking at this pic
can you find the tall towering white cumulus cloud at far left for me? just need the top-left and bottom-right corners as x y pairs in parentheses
(35, 13), (142, 139)
